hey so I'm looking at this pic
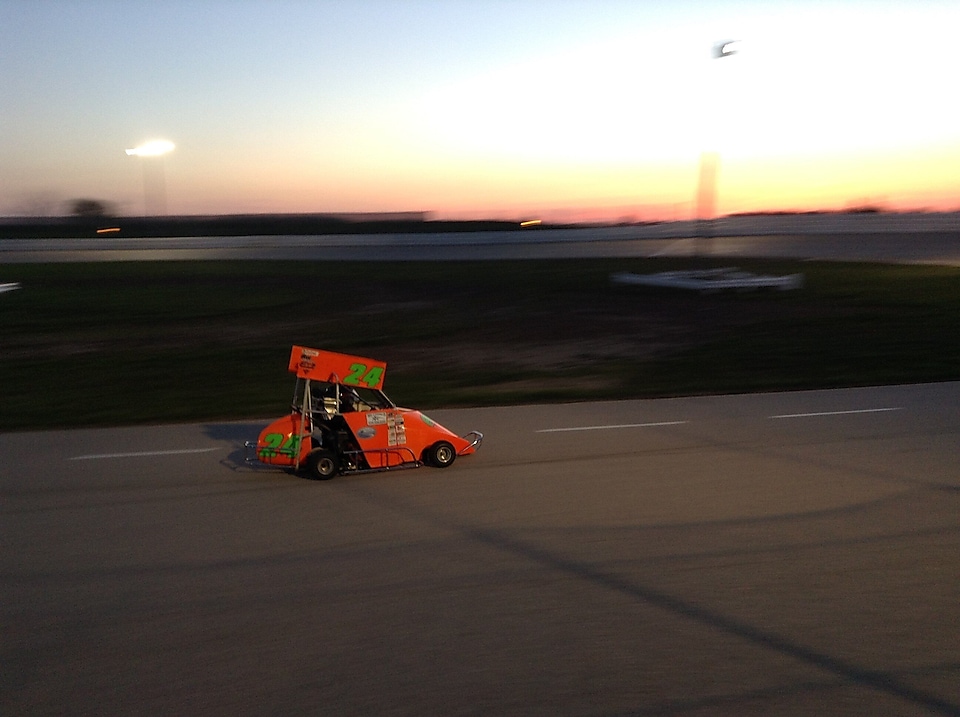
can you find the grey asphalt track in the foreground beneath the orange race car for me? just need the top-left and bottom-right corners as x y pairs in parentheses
(0, 383), (960, 715)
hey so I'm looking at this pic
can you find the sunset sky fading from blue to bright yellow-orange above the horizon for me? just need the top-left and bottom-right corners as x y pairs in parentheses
(0, 0), (960, 219)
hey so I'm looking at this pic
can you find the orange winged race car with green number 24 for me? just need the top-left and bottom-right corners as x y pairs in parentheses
(246, 346), (483, 480)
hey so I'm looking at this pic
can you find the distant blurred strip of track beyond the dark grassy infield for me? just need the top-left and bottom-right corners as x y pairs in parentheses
(0, 222), (960, 266)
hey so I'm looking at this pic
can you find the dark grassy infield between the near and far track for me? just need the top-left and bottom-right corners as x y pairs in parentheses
(0, 259), (960, 431)
